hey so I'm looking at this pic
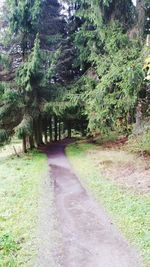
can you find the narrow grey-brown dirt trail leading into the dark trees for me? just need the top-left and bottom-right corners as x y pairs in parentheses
(48, 142), (142, 267)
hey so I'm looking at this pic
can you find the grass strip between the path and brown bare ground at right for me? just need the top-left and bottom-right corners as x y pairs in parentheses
(66, 144), (150, 267)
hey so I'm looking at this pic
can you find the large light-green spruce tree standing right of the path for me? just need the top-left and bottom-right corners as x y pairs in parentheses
(62, 1), (147, 132)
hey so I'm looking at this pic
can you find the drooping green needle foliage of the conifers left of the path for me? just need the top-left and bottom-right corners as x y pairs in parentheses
(0, 0), (62, 147)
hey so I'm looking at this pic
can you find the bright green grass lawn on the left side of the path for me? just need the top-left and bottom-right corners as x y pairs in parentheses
(0, 152), (46, 267)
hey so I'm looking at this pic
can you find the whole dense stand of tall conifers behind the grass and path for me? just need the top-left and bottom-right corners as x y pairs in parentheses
(0, 0), (150, 152)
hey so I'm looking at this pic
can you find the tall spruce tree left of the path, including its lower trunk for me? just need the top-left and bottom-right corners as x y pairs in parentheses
(0, 0), (63, 152)
